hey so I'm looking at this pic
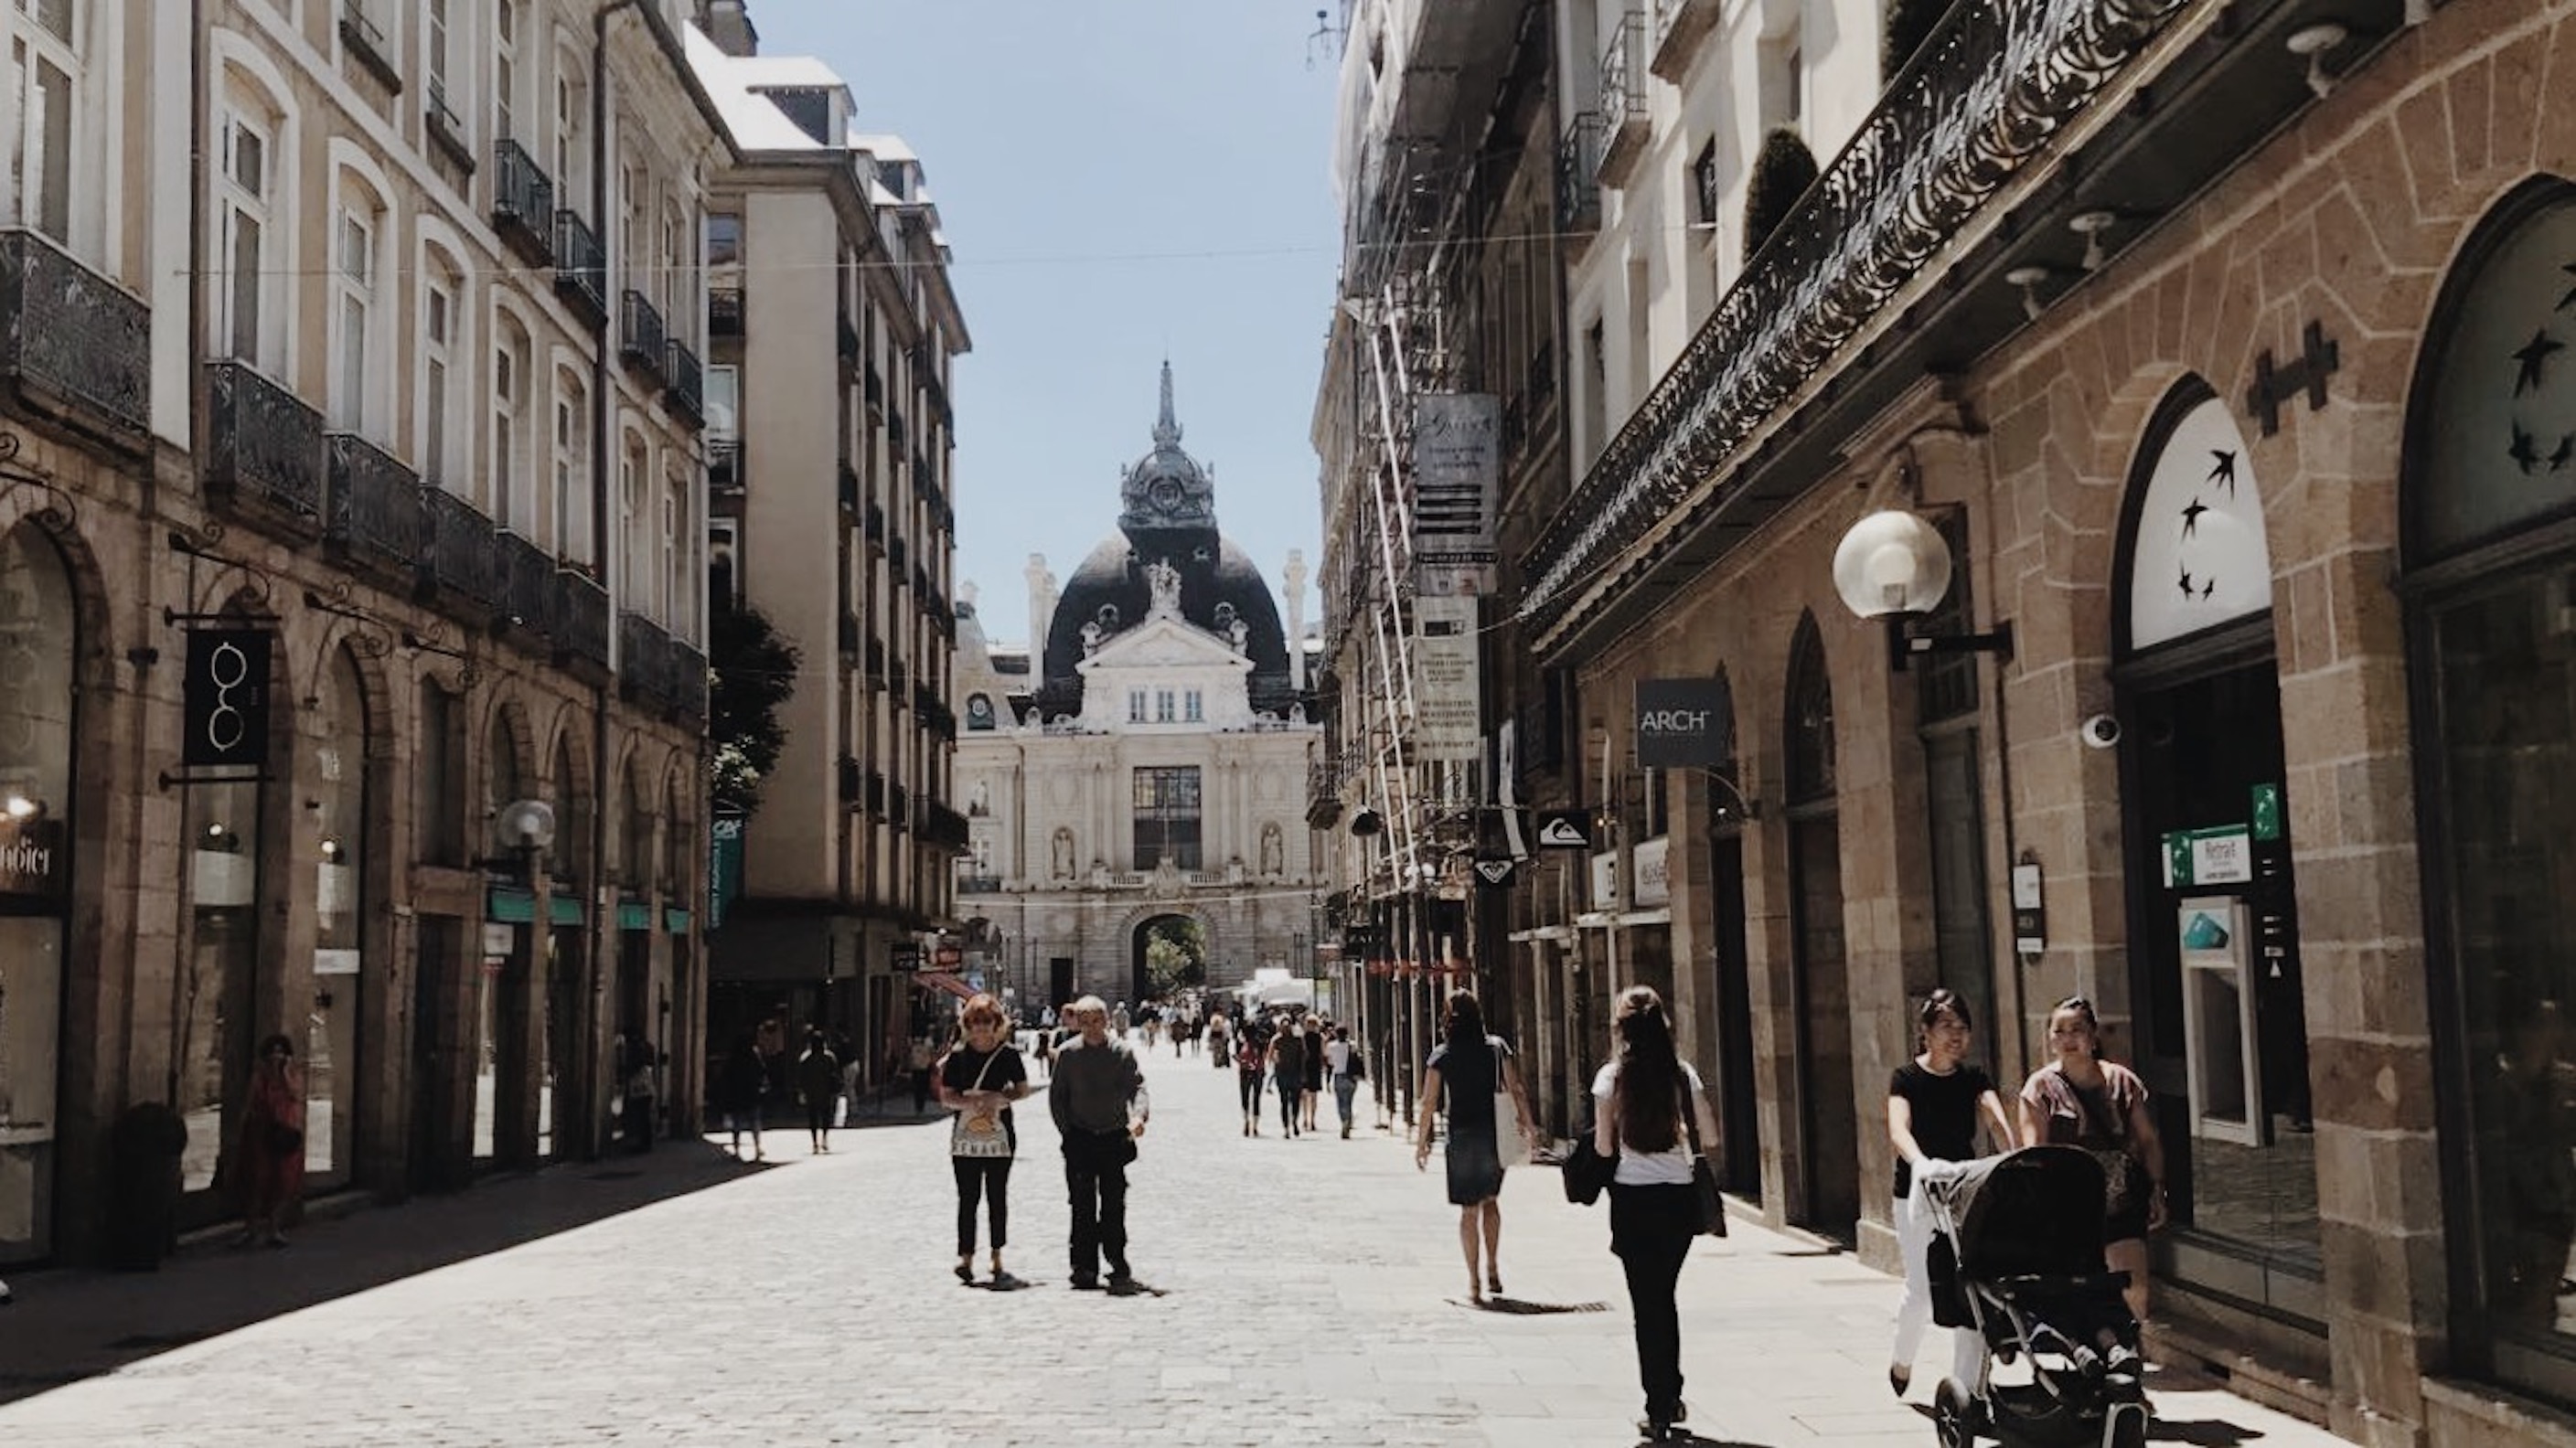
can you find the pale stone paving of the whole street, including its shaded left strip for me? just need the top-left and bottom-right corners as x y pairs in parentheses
(0, 1054), (2336, 1448)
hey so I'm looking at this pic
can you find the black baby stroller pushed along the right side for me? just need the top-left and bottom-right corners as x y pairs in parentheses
(1924, 1146), (2148, 1448)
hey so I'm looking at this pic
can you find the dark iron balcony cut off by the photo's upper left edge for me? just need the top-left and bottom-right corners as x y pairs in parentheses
(0, 227), (152, 448)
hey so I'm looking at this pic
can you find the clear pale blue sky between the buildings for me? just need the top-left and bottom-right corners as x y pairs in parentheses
(750, 0), (1340, 642)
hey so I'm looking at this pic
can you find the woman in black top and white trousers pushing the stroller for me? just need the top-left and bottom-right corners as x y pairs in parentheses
(1888, 989), (2015, 1397)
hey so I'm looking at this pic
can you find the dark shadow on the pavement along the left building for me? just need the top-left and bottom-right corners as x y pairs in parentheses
(0, 1142), (767, 1404)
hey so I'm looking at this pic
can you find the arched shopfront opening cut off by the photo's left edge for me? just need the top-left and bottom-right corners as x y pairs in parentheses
(0, 526), (80, 1262)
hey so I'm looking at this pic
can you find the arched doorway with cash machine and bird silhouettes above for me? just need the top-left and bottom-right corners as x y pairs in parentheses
(2107, 377), (2321, 1319)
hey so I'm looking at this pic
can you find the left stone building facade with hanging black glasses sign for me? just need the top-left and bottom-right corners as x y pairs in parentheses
(0, 0), (724, 1260)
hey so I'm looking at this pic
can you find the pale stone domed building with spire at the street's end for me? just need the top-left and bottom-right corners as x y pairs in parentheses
(953, 363), (1327, 1007)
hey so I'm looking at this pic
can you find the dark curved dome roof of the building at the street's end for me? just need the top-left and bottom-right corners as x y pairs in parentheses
(1038, 533), (1293, 717)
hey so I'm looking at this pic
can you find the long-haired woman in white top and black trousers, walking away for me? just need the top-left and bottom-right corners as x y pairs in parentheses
(1592, 985), (1718, 1441)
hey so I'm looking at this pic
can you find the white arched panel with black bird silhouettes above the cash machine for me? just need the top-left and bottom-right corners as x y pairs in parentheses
(2128, 377), (2272, 649)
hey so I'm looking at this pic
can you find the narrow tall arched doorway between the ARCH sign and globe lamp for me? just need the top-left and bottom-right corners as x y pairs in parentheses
(1785, 613), (1860, 1242)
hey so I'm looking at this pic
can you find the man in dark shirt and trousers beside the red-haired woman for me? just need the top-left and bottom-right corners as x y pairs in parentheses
(1046, 995), (1151, 1296)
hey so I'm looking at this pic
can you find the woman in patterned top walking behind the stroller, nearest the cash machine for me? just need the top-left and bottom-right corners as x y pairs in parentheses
(2022, 995), (2164, 1322)
